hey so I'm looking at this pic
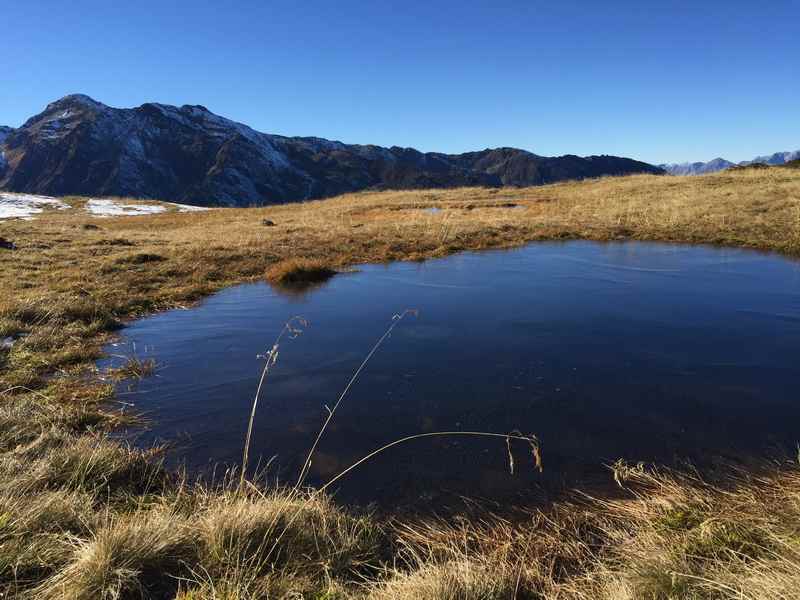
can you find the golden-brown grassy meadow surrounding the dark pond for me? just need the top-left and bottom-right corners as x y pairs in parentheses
(0, 168), (800, 600)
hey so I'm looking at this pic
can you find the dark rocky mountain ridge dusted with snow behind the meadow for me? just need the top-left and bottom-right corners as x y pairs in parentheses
(0, 95), (663, 206)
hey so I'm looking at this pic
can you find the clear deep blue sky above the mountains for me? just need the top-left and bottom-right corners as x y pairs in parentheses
(0, 0), (800, 162)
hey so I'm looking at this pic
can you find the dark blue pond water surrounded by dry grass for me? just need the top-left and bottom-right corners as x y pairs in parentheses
(103, 242), (800, 505)
